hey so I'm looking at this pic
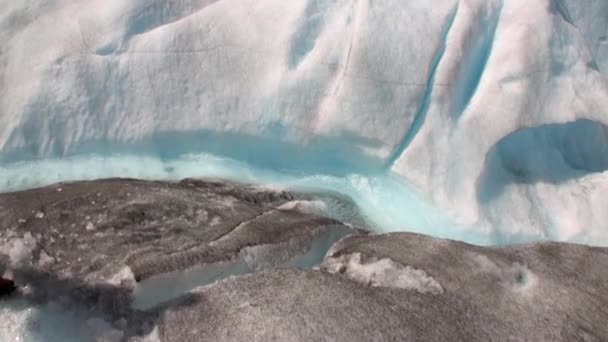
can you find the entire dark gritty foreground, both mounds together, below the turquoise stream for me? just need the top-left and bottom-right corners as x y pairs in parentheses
(0, 179), (608, 341)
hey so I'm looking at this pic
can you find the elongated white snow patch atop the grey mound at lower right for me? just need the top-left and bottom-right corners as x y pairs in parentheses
(321, 253), (443, 294)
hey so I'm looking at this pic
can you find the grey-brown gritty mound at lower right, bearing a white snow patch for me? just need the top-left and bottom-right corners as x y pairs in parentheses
(147, 233), (608, 341)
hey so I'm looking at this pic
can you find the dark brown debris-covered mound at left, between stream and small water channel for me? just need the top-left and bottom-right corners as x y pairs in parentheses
(0, 179), (356, 281)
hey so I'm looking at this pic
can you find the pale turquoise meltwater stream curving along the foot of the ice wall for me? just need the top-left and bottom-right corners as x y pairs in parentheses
(0, 153), (492, 245)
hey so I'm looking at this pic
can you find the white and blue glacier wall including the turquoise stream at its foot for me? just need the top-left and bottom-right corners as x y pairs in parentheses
(0, 0), (608, 245)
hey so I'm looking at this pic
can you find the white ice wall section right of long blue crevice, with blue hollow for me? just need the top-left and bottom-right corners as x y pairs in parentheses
(394, 0), (608, 242)
